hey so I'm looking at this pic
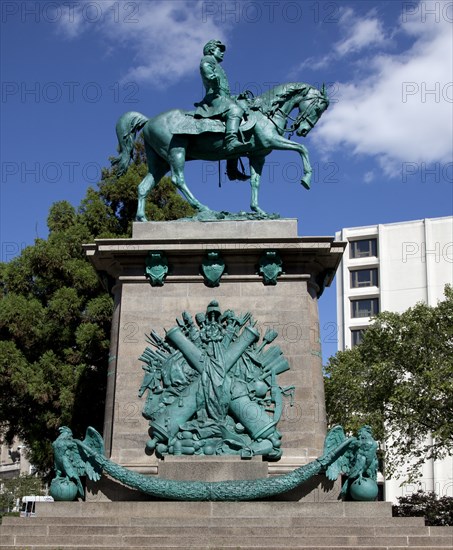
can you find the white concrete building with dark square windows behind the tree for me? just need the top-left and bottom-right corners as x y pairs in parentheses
(335, 217), (453, 502)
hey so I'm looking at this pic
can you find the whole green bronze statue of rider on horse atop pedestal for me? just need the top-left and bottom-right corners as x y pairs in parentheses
(113, 40), (329, 221)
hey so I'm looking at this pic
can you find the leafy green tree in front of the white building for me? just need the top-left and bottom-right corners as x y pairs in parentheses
(325, 285), (453, 479)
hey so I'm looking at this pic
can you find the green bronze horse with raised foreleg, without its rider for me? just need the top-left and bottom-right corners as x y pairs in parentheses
(113, 82), (329, 221)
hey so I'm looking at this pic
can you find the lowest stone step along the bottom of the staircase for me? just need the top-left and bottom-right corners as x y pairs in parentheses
(0, 532), (453, 549)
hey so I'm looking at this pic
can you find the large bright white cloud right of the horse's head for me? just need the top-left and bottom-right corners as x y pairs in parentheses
(313, 6), (453, 176)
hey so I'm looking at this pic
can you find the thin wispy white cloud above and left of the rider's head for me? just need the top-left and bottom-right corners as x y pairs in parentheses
(56, 0), (225, 86)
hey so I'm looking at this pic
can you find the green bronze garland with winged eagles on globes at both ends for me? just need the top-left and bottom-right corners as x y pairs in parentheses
(51, 426), (377, 501)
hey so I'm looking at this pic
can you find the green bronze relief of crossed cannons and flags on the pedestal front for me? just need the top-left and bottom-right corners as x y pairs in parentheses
(139, 300), (294, 460)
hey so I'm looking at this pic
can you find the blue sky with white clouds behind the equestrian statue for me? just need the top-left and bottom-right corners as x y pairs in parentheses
(0, 0), (453, 356)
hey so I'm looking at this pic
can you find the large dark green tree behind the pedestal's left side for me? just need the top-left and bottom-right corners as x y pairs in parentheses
(0, 142), (193, 471)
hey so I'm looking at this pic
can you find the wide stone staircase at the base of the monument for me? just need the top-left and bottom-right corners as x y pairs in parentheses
(0, 501), (453, 550)
